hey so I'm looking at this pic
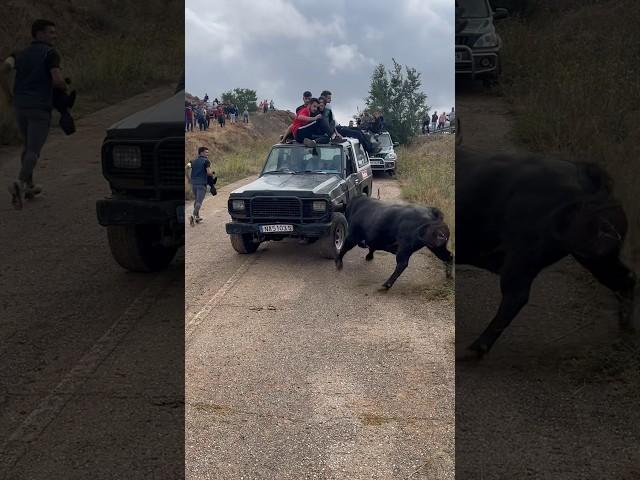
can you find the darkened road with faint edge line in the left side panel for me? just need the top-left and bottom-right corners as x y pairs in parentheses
(0, 88), (184, 479)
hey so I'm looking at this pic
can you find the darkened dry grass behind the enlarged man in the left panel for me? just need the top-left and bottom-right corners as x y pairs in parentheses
(0, 0), (184, 144)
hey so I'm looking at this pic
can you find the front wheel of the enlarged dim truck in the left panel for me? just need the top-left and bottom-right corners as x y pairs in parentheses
(107, 225), (178, 272)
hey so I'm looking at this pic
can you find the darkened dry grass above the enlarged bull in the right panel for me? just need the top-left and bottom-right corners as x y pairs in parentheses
(502, 0), (640, 268)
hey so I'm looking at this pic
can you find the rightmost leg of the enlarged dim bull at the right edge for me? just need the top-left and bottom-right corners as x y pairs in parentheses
(574, 255), (637, 331)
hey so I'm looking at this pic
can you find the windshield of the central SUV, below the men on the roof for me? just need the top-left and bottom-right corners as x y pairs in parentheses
(262, 145), (342, 174)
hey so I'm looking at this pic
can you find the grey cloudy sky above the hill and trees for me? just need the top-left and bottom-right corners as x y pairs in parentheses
(185, 0), (455, 124)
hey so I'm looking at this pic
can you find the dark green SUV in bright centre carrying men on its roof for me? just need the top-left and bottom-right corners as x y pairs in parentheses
(226, 138), (373, 258)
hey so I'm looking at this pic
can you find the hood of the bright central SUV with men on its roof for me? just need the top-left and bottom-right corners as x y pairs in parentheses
(231, 173), (343, 196)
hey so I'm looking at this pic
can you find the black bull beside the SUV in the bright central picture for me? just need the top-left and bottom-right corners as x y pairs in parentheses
(336, 195), (453, 290)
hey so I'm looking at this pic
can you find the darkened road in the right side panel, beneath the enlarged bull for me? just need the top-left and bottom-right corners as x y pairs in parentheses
(456, 87), (640, 480)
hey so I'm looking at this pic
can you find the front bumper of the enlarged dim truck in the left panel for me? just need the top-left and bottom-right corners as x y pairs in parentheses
(96, 198), (184, 227)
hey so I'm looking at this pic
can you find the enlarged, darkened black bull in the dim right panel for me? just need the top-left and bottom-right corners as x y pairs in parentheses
(456, 147), (636, 356)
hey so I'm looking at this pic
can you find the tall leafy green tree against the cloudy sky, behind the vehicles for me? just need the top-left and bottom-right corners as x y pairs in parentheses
(365, 59), (429, 143)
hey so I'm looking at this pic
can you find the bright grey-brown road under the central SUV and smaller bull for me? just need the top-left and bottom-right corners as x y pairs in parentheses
(186, 180), (454, 480)
